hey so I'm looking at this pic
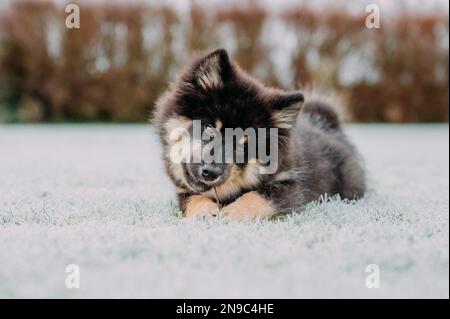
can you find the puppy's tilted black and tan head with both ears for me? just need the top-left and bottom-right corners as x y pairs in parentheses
(155, 49), (303, 197)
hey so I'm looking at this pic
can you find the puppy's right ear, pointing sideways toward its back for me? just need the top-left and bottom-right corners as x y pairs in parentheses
(271, 92), (305, 129)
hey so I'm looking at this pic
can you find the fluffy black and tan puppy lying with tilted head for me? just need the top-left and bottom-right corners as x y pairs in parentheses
(154, 49), (365, 219)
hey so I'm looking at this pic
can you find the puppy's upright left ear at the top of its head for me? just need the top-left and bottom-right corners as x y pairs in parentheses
(193, 49), (232, 91)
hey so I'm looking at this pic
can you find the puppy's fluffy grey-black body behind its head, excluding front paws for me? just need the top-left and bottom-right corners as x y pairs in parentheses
(262, 97), (366, 209)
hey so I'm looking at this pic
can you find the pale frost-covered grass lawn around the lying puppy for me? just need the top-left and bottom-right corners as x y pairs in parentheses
(0, 125), (449, 298)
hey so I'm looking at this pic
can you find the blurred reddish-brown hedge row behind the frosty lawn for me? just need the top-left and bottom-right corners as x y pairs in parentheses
(0, 0), (449, 122)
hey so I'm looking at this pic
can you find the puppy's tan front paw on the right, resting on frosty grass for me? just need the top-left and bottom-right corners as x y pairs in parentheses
(220, 192), (276, 220)
